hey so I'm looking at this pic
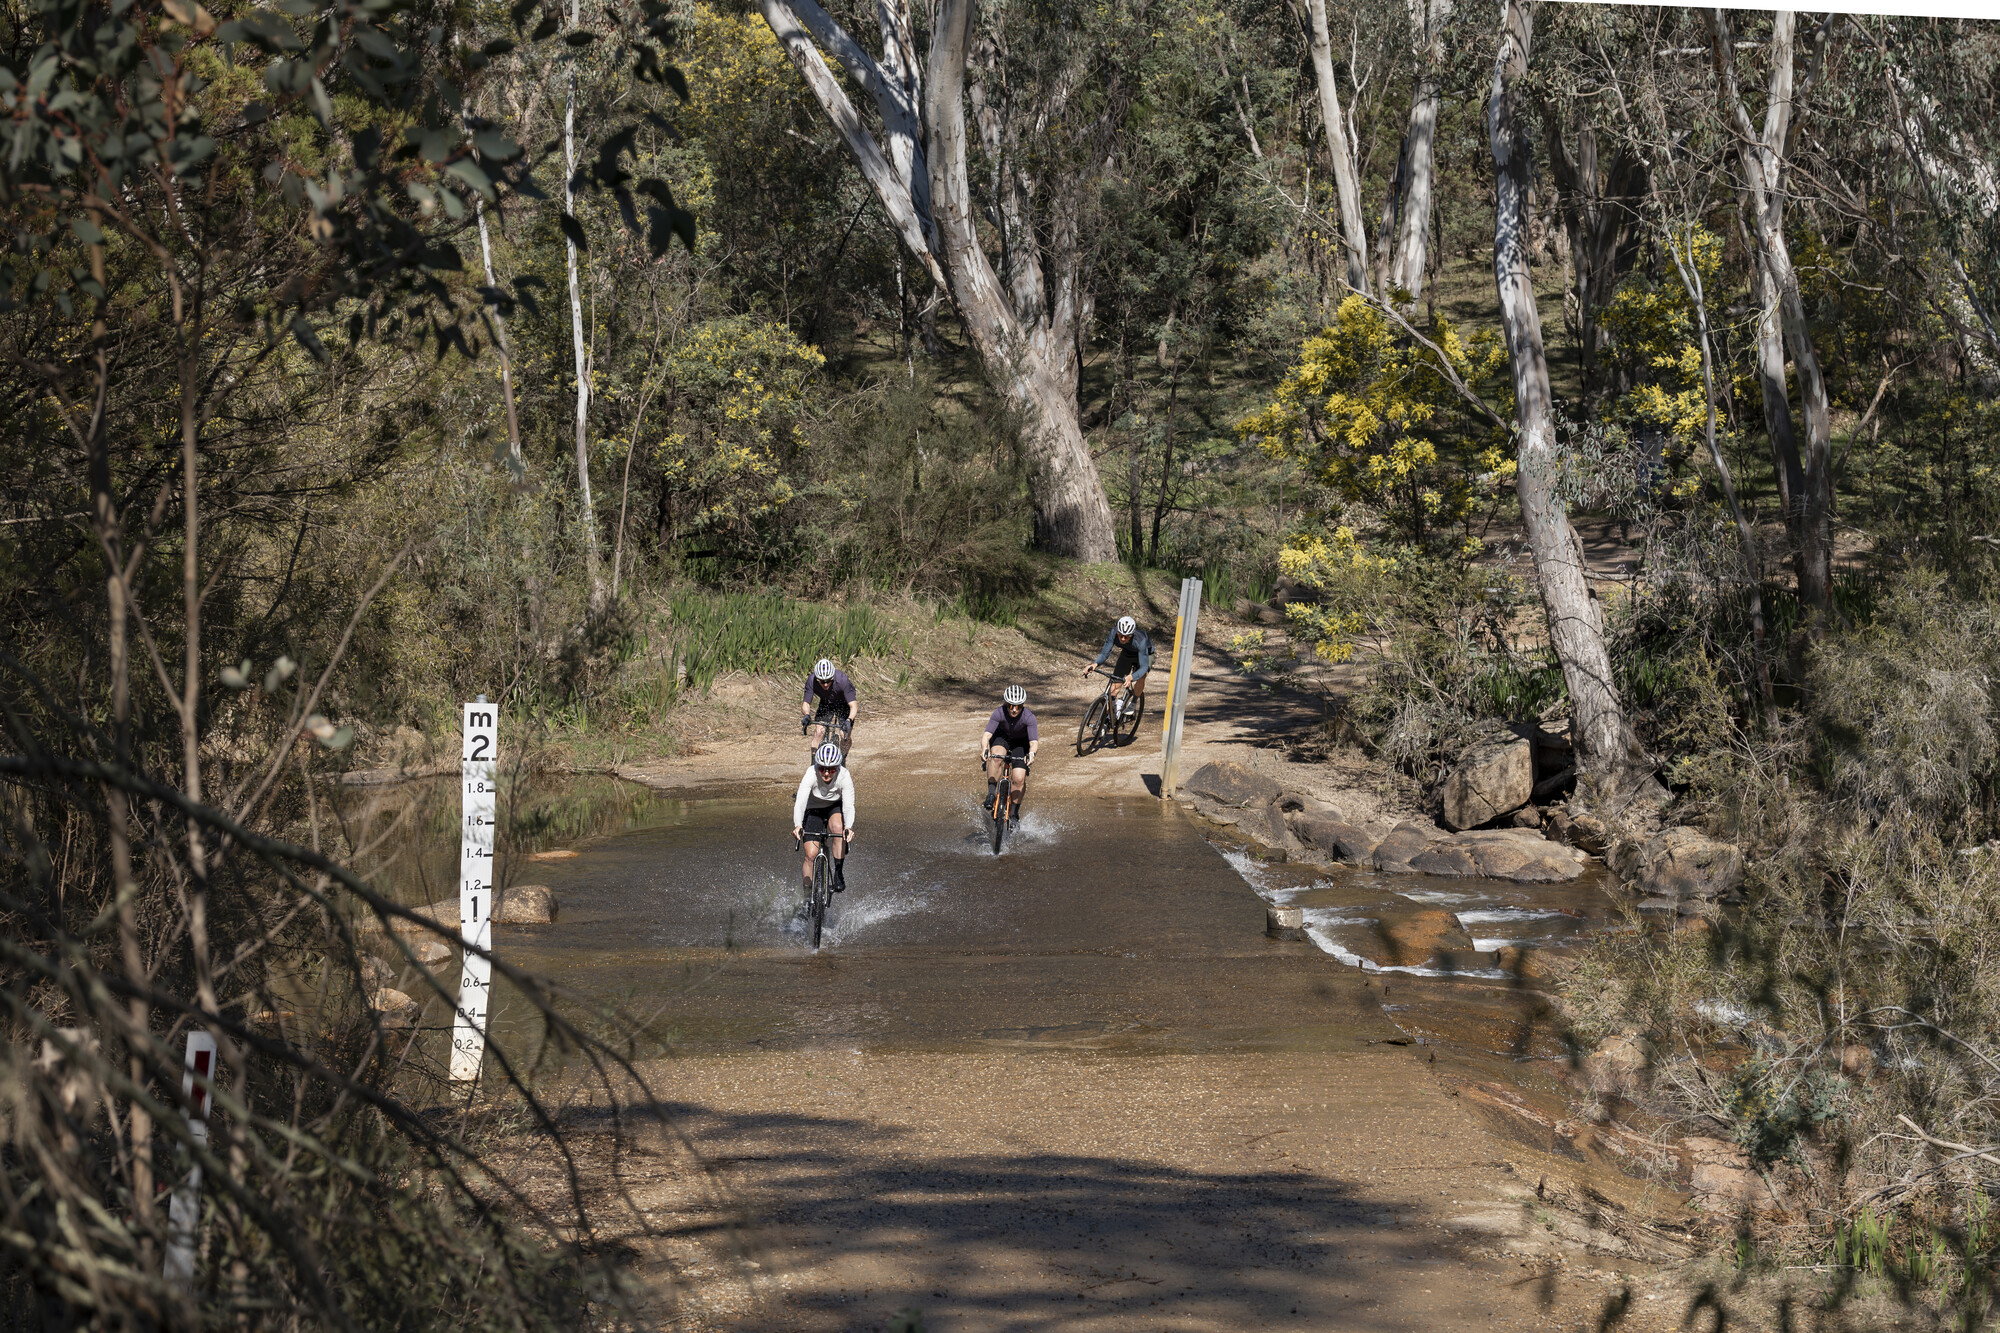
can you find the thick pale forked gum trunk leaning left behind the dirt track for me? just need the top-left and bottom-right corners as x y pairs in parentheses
(758, 0), (1118, 560)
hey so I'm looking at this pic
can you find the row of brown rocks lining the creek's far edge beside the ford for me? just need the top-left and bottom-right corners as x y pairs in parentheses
(1180, 761), (1588, 883)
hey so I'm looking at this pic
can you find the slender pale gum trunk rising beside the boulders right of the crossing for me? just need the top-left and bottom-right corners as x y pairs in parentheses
(1486, 0), (1652, 797)
